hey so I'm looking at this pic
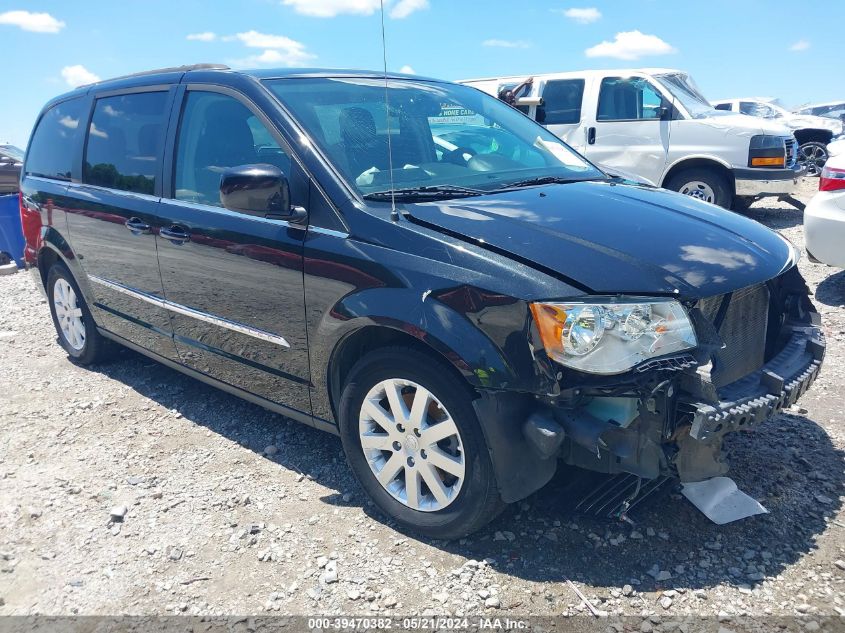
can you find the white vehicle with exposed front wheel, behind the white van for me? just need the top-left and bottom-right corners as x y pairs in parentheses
(712, 97), (845, 176)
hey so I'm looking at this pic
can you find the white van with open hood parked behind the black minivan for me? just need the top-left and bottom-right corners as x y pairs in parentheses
(461, 68), (803, 207)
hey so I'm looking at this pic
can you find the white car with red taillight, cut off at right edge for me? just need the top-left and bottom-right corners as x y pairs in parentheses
(804, 151), (845, 268)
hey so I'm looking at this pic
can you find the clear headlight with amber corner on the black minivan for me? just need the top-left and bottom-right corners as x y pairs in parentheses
(531, 299), (698, 374)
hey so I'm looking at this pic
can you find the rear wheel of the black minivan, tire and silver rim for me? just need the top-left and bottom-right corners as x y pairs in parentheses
(46, 264), (114, 365)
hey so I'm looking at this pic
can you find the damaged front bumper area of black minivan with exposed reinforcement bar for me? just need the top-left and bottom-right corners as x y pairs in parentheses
(522, 271), (825, 483)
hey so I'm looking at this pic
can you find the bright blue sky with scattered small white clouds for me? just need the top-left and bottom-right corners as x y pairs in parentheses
(0, 0), (845, 146)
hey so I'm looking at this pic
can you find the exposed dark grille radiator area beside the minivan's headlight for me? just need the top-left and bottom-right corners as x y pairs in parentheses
(698, 284), (769, 387)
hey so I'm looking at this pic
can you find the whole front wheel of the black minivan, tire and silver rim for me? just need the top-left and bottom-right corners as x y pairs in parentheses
(338, 347), (504, 539)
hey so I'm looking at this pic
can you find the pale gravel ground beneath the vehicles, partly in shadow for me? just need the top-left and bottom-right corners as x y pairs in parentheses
(0, 181), (845, 631)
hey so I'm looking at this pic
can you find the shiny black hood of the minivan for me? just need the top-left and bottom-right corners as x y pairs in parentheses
(405, 181), (797, 299)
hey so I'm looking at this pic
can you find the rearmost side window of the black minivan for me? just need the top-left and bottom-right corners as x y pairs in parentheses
(26, 99), (83, 180)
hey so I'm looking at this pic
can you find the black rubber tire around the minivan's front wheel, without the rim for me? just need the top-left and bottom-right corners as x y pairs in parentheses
(338, 347), (505, 540)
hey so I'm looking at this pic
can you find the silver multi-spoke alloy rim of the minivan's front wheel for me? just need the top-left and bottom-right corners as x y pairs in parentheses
(358, 378), (466, 512)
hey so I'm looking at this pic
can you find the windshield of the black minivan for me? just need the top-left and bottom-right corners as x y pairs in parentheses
(266, 77), (606, 195)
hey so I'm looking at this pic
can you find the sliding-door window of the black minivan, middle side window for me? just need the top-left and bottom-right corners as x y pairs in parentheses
(82, 92), (168, 195)
